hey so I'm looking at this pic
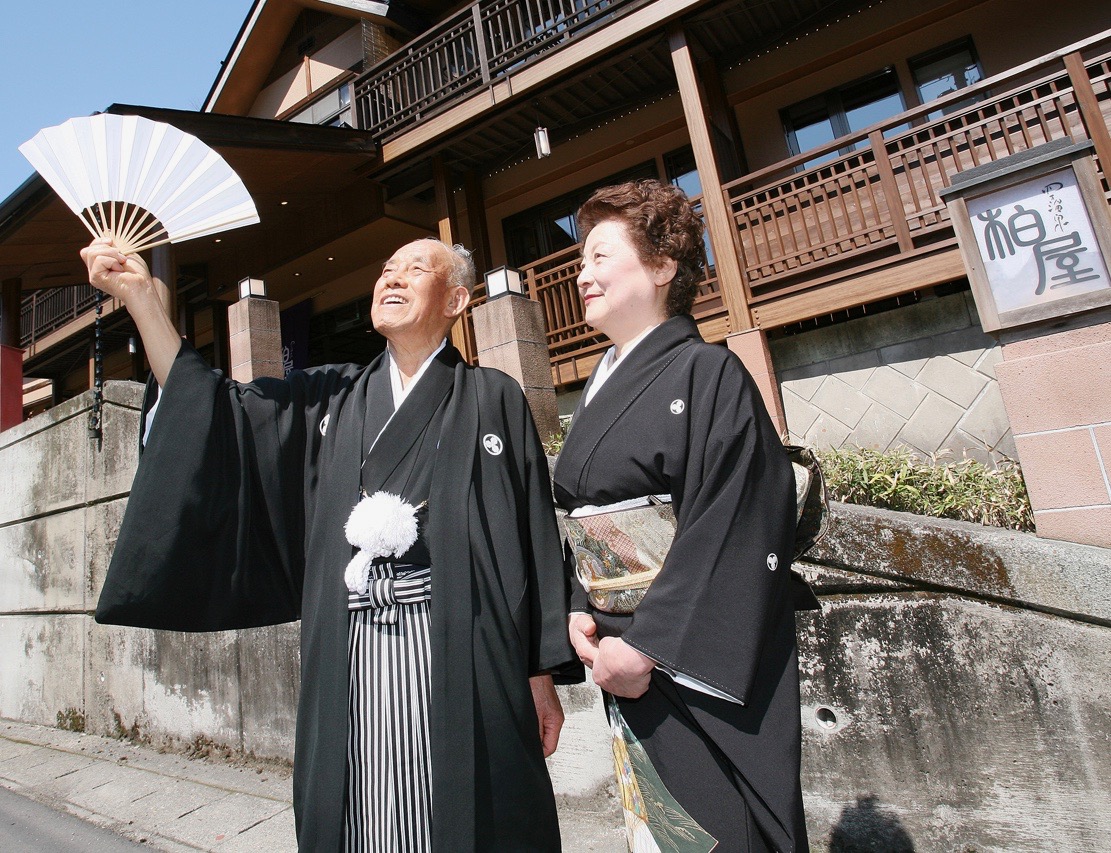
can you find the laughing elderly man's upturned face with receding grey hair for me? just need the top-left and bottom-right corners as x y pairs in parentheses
(370, 240), (467, 345)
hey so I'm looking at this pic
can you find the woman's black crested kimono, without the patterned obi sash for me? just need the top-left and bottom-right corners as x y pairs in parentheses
(554, 315), (808, 852)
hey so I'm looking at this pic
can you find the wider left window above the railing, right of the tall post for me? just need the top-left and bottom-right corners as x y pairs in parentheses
(782, 68), (907, 169)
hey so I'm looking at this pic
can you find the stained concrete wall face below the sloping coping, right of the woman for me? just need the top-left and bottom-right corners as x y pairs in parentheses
(799, 593), (1111, 853)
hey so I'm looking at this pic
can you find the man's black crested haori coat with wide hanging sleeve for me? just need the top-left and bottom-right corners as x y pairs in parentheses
(97, 344), (573, 853)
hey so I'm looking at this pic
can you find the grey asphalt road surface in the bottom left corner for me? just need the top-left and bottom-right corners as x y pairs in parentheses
(0, 787), (150, 853)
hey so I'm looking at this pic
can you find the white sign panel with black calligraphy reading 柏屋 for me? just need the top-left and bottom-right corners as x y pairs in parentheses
(968, 168), (1111, 314)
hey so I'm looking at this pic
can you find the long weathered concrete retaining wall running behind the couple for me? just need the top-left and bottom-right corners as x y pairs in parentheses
(0, 383), (1111, 852)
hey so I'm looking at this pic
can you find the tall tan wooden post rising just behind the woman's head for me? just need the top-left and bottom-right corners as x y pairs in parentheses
(668, 27), (753, 332)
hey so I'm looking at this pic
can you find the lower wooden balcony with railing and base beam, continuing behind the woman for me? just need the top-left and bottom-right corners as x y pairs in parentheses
(513, 33), (1111, 387)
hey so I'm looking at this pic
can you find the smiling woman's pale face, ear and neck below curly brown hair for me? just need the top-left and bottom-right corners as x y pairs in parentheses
(579, 219), (675, 348)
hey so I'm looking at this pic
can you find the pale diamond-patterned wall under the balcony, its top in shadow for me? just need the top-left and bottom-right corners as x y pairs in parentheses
(769, 293), (1015, 463)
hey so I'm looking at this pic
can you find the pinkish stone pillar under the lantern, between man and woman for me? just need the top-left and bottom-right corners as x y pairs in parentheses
(473, 294), (560, 440)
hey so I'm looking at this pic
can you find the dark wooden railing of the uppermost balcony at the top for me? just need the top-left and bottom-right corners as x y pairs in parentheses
(354, 0), (645, 139)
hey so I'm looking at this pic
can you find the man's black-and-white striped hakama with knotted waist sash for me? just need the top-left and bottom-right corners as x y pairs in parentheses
(344, 563), (432, 853)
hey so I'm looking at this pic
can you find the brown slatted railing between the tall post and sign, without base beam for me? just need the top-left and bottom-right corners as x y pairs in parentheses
(722, 37), (1111, 305)
